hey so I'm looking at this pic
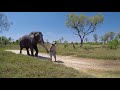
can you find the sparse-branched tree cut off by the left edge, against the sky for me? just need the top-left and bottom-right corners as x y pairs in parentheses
(0, 13), (12, 32)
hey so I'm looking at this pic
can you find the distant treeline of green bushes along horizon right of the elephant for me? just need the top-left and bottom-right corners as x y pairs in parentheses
(46, 32), (120, 49)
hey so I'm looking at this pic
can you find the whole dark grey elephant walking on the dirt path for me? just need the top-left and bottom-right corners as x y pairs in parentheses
(20, 32), (49, 56)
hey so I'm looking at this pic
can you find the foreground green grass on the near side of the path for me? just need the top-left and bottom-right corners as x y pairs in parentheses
(0, 47), (93, 78)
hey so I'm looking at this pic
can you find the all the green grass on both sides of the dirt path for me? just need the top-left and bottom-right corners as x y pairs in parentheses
(0, 45), (120, 78)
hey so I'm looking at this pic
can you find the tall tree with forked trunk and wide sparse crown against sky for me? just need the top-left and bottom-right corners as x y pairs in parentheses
(66, 14), (104, 47)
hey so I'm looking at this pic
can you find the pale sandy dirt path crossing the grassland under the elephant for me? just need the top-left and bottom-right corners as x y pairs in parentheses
(6, 50), (120, 71)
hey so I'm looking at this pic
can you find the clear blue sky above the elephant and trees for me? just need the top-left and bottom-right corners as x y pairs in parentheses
(0, 12), (120, 42)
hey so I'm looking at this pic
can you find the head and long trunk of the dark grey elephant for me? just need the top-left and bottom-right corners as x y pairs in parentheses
(29, 32), (49, 53)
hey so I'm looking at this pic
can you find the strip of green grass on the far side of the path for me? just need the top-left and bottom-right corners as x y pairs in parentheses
(3, 44), (120, 60)
